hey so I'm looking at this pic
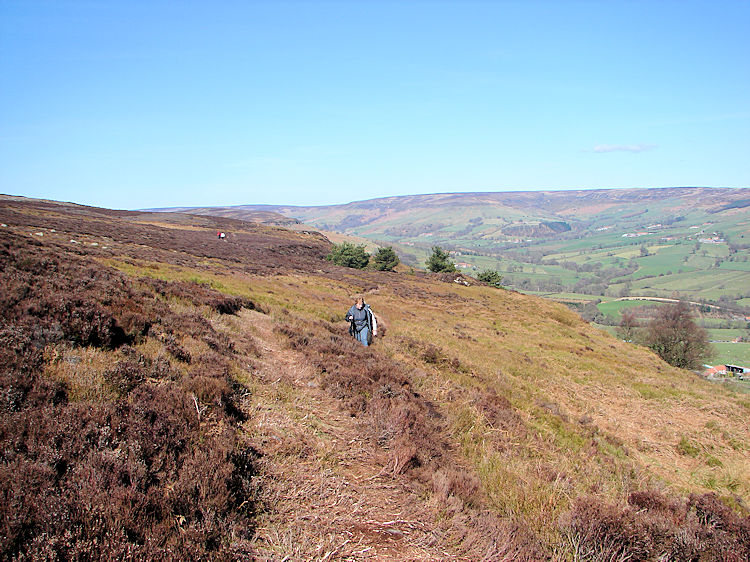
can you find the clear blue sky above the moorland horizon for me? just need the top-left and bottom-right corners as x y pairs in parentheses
(0, 0), (750, 209)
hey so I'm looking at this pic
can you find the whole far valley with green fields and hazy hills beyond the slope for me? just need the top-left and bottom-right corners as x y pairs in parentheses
(164, 187), (750, 365)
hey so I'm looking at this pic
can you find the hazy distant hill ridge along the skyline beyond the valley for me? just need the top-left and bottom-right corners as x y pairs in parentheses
(154, 187), (750, 242)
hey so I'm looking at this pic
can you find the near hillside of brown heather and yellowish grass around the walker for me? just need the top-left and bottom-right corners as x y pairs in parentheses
(0, 197), (750, 561)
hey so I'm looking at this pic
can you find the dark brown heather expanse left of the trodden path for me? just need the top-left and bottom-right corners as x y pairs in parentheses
(0, 226), (256, 560)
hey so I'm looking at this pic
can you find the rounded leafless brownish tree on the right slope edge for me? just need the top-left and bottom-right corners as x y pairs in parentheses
(644, 301), (713, 369)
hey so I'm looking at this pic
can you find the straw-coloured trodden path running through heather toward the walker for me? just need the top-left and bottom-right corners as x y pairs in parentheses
(231, 311), (460, 560)
